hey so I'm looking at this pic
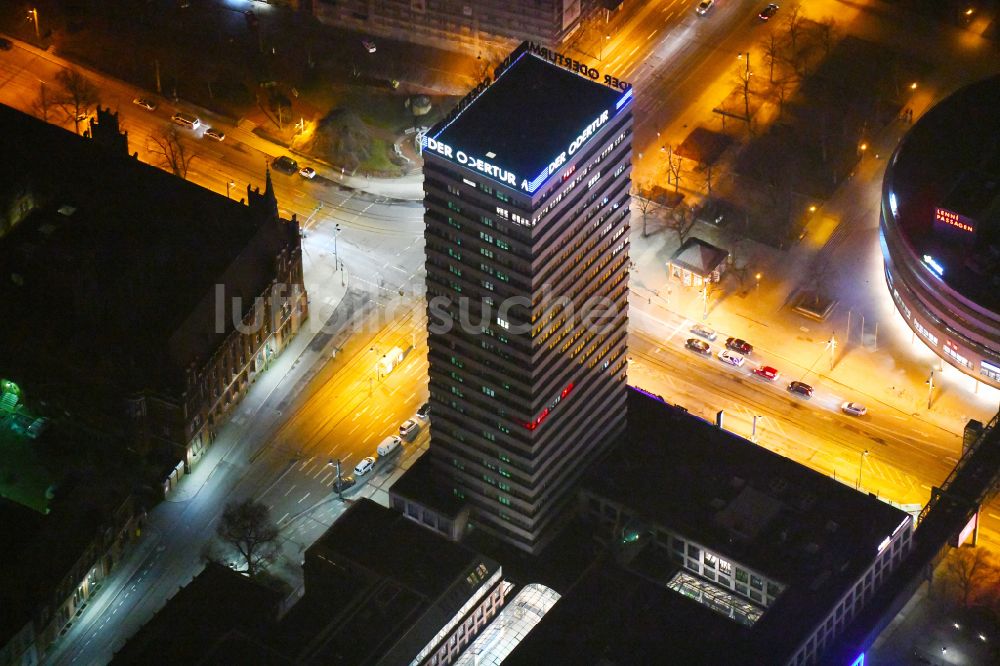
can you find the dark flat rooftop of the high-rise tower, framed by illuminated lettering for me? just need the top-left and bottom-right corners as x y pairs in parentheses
(430, 46), (625, 189)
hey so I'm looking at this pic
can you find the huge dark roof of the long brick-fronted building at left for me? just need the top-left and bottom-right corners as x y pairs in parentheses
(0, 106), (296, 408)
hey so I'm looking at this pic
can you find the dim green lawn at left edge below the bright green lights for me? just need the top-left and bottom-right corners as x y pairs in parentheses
(0, 413), (54, 514)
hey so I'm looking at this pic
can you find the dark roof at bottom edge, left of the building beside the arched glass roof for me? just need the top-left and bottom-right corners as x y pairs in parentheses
(111, 562), (284, 664)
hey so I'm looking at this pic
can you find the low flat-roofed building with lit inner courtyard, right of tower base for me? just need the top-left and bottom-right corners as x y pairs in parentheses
(505, 389), (913, 664)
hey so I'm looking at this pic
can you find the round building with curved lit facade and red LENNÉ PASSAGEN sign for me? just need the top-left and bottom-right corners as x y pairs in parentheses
(880, 76), (1000, 387)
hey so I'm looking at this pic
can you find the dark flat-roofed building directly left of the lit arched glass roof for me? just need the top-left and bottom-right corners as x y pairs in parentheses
(279, 498), (499, 666)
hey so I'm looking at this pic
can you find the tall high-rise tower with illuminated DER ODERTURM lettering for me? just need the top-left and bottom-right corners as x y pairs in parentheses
(400, 43), (632, 552)
